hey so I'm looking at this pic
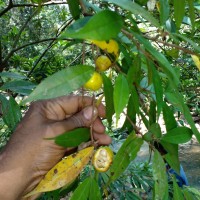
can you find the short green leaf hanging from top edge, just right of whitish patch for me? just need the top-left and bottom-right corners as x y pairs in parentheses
(159, 0), (170, 26)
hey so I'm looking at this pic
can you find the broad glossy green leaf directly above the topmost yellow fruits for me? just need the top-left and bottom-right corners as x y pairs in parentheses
(60, 10), (123, 40)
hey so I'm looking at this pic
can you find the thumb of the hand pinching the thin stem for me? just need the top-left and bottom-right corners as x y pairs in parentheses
(51, 106), (98, 135)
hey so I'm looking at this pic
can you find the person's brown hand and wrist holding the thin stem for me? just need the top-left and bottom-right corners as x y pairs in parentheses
(0, 96), (111, 200)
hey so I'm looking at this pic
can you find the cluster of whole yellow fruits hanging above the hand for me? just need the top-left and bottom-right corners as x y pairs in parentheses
(84, 39), (119, 91)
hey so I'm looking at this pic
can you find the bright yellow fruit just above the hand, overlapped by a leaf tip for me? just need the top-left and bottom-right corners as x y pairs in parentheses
(84, 72), (103, 91)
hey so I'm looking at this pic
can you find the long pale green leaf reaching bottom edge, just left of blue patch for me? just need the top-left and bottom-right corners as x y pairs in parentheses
(153, 150), (168, 200)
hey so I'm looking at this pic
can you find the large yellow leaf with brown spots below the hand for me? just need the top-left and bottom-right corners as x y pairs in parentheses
(24, 147), (94, 198)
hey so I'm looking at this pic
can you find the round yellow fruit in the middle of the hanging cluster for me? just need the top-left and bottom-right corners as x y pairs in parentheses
(95, 55), (112, 72)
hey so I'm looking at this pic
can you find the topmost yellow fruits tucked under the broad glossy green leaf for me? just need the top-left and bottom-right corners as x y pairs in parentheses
(92, 40), (119, 57)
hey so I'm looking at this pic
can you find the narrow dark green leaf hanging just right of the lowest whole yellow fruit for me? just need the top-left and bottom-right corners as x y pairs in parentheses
(102, 74), (115, 127)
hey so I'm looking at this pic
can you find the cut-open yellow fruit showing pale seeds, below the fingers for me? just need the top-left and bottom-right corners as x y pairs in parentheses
(92, 147), (113, 172)
